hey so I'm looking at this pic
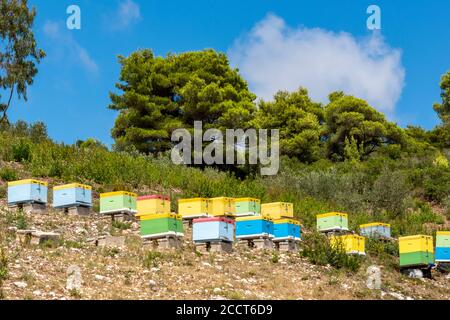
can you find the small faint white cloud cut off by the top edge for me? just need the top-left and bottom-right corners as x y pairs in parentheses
(104, 0), (142, 31)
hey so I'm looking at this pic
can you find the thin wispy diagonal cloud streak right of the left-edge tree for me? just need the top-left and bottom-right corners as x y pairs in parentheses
(44, 21), (99, 76)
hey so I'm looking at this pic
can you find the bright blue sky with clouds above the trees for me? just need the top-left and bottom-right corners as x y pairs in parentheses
(10, 0), (450, 144)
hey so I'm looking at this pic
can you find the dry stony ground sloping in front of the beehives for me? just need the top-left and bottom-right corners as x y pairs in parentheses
(0, 206), (450, 299)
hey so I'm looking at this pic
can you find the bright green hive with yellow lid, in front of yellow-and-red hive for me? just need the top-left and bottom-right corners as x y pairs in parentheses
(136, 213), (184, 239)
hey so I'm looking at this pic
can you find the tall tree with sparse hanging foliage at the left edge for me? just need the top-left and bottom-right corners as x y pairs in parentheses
(0, 0), (45, 122)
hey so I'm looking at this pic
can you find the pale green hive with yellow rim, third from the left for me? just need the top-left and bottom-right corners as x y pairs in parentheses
(100, 191), (137, 214)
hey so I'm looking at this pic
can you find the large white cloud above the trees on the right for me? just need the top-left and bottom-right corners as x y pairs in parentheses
(229, 15), (405, 114)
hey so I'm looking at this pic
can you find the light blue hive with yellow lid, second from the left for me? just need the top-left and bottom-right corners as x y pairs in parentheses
(53, 183), (92, 208)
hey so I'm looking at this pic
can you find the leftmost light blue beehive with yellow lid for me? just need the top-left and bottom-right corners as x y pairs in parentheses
(8, 179), (48, 205)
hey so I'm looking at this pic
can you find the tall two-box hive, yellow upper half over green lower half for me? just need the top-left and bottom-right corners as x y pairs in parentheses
(398, 235), (434, 267)
